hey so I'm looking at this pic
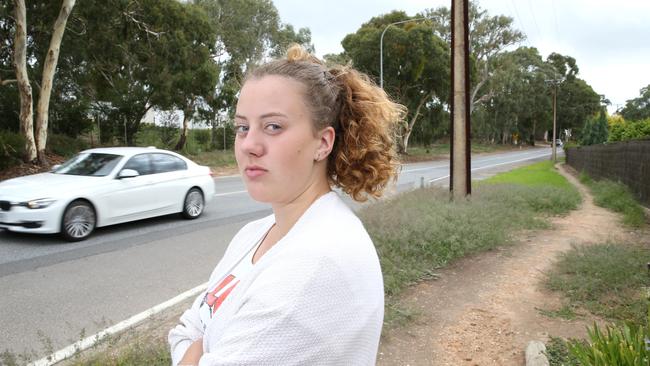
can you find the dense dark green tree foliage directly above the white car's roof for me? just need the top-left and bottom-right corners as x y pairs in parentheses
(72, 0), (218, 145)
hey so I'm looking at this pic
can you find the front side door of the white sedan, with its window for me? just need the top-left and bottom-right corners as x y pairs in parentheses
(107, 153), (157, 224)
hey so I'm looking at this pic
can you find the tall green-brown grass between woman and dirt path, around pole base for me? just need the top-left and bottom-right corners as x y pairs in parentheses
(360, 184), (580, 304)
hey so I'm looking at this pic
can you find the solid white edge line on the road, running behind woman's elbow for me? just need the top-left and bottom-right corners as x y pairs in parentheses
(29, 282), (208, 366)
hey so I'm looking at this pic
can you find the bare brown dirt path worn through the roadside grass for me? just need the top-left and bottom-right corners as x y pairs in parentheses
(378, 166), (632, 366)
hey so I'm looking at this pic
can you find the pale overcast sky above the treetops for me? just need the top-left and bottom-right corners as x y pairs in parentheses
(273, 0), (650, 110)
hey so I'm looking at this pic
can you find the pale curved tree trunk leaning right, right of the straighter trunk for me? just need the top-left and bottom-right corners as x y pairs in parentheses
(36, 0), (75, 165)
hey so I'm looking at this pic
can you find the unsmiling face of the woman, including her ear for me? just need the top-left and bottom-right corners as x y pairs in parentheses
(235, 75), (334, 203)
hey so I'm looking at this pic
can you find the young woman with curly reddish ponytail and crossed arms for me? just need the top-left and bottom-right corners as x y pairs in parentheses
(169, 46), (403, 365)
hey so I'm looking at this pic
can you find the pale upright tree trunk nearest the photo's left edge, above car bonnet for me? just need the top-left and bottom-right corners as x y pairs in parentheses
(14, 0), (36, 162)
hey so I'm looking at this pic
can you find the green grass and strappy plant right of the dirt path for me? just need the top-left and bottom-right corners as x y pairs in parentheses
(546, 243), (650, 366)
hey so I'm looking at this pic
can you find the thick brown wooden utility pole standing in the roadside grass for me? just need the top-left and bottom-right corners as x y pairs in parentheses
(449, 0), (472, 199)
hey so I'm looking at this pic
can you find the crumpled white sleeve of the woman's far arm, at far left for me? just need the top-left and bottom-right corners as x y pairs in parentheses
(167, 292), (204, 366)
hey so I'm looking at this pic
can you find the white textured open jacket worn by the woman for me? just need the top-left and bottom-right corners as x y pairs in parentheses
(169, 192), (384, 366)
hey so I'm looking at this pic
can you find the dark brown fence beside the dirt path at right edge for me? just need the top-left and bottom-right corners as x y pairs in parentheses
(566, 140), (650, 206)
